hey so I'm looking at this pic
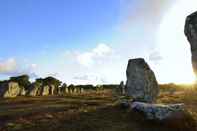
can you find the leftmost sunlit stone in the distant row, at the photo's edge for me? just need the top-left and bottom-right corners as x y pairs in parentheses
(0, 82), (22, 98)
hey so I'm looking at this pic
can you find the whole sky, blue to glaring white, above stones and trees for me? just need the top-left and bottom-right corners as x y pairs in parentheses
(0, 0), (197, 84)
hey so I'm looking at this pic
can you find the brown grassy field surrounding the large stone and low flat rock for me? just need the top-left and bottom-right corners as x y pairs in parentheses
(0, 85), (197, 131)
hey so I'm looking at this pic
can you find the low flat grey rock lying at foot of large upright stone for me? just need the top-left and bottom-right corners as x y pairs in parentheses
(131, 102), (185, 121)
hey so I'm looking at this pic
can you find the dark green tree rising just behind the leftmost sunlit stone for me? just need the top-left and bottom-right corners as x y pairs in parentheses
(9, 75), (31, 88)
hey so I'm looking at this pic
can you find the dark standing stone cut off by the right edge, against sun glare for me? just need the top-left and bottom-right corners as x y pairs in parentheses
(185, 12), (197, 76)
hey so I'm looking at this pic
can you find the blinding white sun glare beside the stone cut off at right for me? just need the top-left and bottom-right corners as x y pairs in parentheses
(158, 0), (197, 83)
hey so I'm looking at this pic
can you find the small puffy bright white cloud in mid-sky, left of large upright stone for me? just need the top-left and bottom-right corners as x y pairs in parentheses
(77, 43), (112, 67)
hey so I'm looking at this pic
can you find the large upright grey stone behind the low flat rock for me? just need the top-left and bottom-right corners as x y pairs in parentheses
(126, 58), (159, 103)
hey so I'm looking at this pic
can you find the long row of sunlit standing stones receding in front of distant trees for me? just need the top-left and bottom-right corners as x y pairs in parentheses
(0, 81), (106, 98)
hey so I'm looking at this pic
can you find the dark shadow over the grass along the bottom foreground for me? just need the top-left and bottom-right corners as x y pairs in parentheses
(2, 105), (196, 131)
